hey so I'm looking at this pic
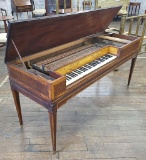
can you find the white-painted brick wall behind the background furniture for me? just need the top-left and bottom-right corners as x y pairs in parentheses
(0, 0), (146, 28)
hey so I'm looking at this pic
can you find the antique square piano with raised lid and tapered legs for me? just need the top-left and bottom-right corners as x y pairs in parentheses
(5, 6), (140, 151)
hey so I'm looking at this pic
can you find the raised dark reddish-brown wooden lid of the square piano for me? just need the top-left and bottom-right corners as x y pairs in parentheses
(5, 6), (121, 63)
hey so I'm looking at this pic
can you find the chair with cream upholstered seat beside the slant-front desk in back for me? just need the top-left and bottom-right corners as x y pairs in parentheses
(31, 0), (46, 17)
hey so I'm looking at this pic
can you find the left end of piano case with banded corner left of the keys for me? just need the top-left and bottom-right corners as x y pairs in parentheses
(8, 65), (66, 100)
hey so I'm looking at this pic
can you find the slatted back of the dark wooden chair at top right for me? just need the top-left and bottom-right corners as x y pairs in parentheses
(128, 2), (141, 16)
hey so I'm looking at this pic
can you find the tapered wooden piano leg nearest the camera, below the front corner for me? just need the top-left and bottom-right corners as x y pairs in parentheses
(49, 111), (57, 153)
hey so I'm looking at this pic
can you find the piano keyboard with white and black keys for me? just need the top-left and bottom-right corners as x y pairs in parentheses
(66, 54), (117, 86)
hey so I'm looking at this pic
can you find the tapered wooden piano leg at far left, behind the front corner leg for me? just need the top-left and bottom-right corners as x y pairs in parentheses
(11, 88), (23, 126)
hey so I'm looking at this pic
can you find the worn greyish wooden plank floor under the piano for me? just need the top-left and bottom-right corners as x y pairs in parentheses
(0, 18), (146, 160)
